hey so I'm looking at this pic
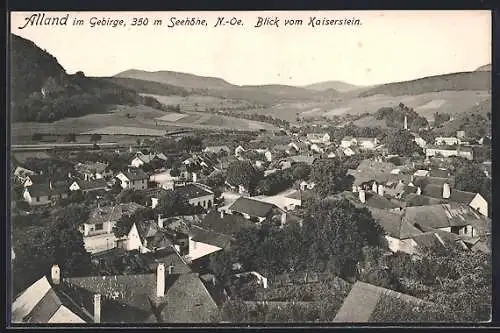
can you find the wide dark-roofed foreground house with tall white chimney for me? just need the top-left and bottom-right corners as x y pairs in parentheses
(53, 263), (218, 324)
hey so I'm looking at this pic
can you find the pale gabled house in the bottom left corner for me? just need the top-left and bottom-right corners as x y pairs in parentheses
(11, 272), (88, 324)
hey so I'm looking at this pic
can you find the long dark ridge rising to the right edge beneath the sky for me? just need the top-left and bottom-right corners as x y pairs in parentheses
(359, 71), (491, 97)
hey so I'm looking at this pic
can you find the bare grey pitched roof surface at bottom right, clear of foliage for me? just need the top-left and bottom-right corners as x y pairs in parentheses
(333, 281), (440, 323)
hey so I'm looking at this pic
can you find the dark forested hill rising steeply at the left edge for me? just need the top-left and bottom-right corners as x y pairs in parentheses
(10, 34), (163, 122)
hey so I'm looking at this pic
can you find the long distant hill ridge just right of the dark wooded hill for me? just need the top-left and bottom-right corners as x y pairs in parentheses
(114, 69), (235, 89)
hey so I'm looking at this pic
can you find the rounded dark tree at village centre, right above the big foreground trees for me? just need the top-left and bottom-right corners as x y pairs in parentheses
(310, 158), (353, 197)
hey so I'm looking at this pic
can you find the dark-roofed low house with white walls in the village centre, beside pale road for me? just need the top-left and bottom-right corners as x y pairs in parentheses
(228, 197), (286, 224)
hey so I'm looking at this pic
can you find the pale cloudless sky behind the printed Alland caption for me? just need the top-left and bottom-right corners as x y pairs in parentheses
(11, 11), (491, 86)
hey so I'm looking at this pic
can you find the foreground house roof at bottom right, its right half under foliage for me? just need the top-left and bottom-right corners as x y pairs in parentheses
(333, 281), (449, 323)
